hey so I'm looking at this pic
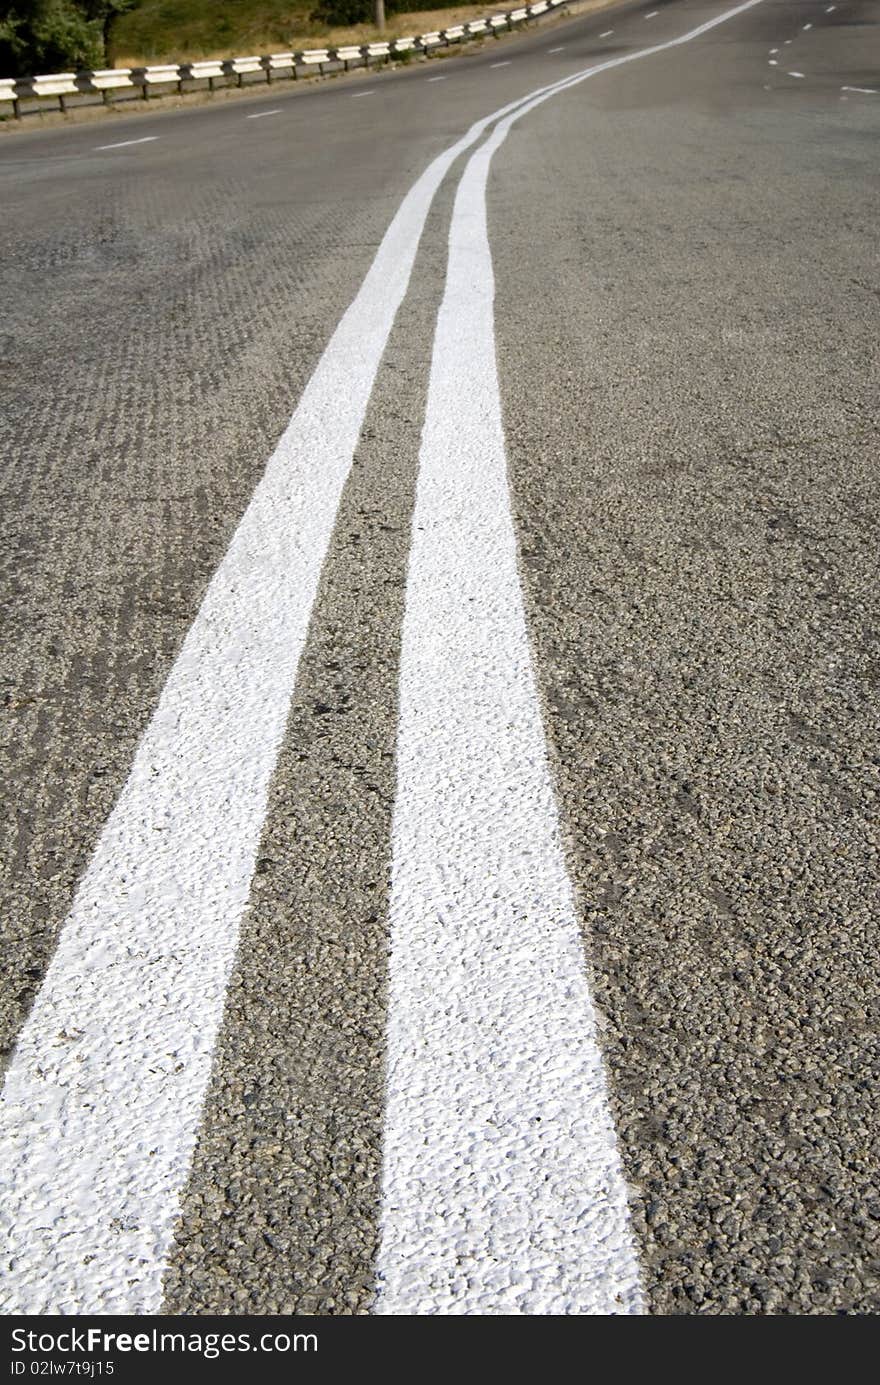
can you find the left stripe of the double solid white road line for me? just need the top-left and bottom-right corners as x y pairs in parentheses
(0, 78), (573, 1313)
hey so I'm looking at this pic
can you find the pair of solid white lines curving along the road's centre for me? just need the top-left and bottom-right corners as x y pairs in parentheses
(0, 0), (761, 1313)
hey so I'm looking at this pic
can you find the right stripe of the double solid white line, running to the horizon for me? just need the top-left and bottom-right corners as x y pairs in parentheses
(376, 0), (761, 1316)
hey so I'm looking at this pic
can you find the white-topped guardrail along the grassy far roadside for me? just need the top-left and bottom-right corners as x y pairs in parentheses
(0, 0), (567, 119)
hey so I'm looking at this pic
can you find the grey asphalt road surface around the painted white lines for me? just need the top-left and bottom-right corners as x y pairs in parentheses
(0, 0), (880, 1314)
